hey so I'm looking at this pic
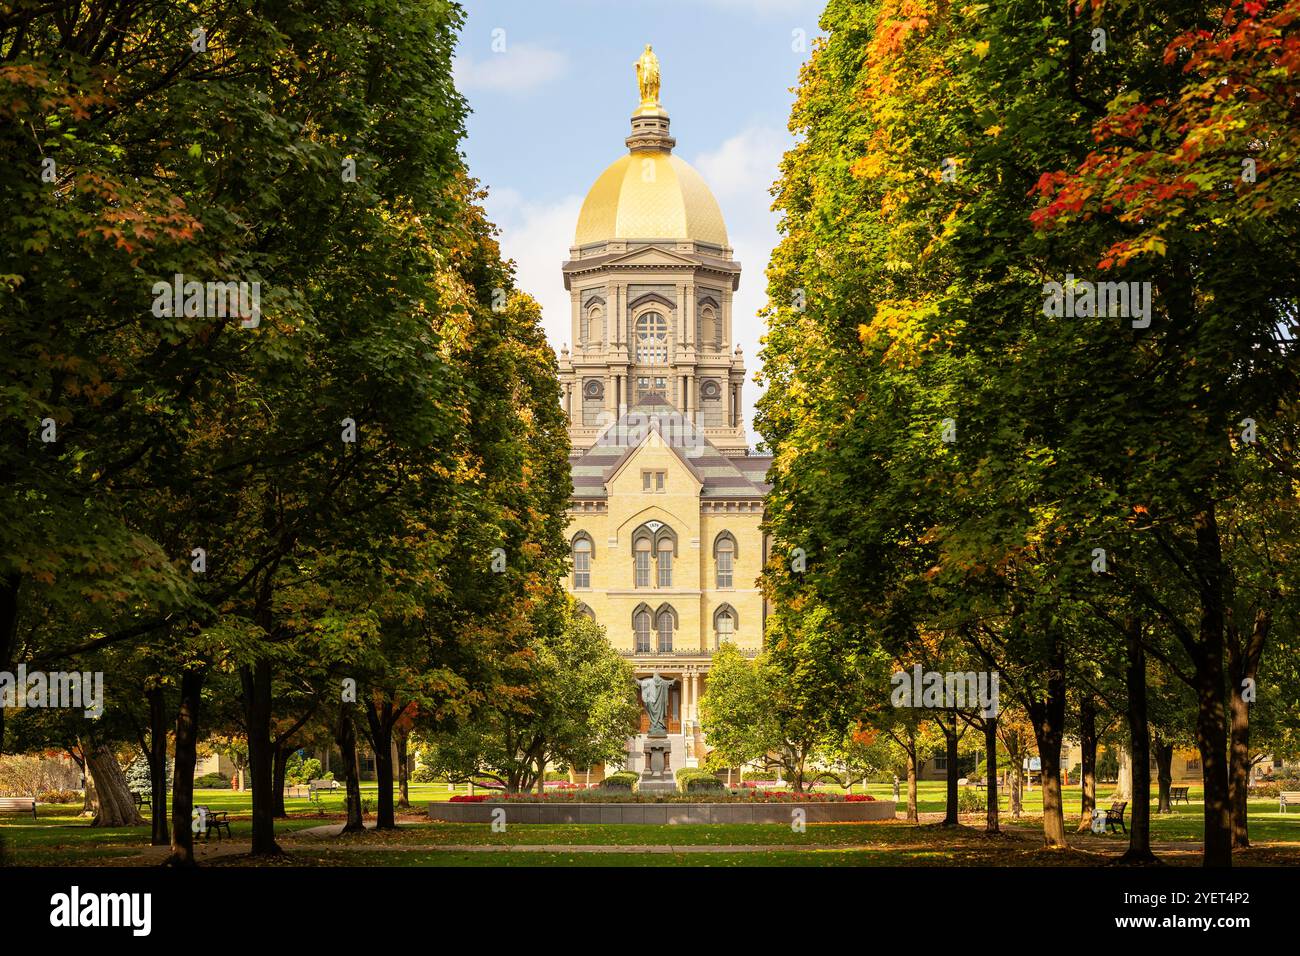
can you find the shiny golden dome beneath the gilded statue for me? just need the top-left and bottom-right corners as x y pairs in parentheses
(573, 150), (727, 247)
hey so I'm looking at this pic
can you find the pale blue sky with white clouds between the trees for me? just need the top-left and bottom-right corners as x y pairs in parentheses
(455, 0), (823, 445)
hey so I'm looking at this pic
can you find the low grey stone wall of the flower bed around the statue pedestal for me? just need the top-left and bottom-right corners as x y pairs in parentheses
(429, 800), (896, 825)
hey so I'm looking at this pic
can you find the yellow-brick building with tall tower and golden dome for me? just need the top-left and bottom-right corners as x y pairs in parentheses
(559, 51), (771, 770)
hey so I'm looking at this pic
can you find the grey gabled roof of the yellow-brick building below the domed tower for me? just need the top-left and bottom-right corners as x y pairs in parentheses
(569, 398), (772, 498)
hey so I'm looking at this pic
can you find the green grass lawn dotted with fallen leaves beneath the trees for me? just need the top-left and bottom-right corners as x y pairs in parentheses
(0, 782), (1300, 866)
